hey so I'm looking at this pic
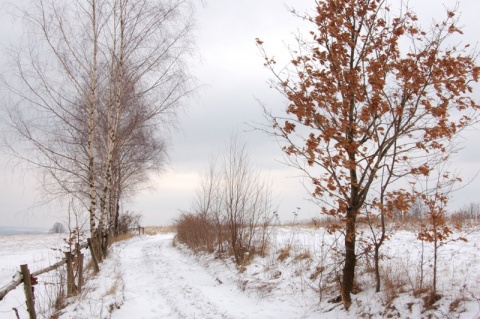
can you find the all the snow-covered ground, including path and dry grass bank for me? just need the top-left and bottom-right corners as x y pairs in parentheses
(0, 227), (480, 319)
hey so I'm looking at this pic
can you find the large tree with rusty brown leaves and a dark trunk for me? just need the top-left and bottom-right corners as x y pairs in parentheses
(257, 0), (480, 309)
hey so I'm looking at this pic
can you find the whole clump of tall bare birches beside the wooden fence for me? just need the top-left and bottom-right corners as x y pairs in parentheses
(4, 0), (194, 258)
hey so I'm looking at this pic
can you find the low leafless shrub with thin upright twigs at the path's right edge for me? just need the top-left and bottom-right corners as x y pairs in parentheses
(183, 136), (274, 266)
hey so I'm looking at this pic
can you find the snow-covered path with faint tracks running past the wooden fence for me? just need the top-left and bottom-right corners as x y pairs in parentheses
(111, 234), (298, 319)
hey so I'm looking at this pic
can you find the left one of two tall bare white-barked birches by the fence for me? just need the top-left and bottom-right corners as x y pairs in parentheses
(4, 0), (106, 248)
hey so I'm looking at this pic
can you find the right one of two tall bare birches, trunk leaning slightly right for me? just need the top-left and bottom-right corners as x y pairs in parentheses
(94, 0), (196, 250)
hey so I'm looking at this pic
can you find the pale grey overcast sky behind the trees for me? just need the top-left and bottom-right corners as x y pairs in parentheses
(0, 0), (480, 228)
